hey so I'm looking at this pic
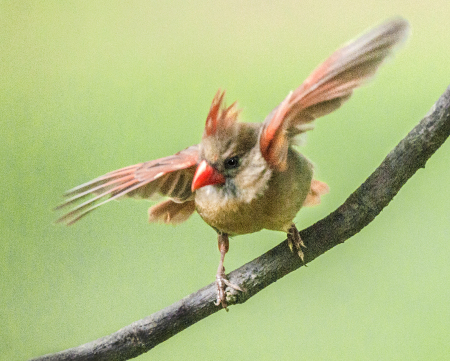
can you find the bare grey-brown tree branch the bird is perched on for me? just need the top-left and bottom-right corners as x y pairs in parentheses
(34, 87), (450, 360)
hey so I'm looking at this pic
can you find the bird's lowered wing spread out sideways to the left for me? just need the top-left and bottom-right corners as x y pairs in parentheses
(56, 145), (198, 225)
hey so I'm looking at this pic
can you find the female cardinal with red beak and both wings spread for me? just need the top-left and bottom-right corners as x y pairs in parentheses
(57, 19), (408, 308)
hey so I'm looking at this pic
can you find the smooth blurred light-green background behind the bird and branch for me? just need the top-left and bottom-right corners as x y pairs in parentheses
(0, 0), (450, 360)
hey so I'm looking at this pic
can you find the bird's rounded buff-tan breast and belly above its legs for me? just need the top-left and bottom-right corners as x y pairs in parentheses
(195, 150), (312, 235)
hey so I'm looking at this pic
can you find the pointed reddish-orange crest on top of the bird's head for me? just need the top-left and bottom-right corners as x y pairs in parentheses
(203, 89), (240, 137)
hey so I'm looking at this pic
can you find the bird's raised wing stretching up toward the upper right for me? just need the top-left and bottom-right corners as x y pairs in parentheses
(260, 19), (409, 170)
